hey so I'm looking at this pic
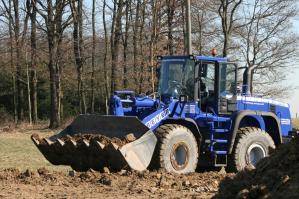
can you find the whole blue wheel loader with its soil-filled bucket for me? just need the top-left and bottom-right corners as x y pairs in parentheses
(31, 55), (295, 174)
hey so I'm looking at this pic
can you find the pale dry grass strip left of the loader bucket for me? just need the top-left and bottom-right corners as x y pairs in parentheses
(0, 127), (70, 171)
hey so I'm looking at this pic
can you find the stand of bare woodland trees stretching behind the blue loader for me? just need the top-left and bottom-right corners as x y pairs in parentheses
(0, 0), (298, 128)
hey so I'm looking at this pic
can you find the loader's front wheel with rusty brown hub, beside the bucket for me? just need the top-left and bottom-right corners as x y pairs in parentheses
(154, 124), (198, 174)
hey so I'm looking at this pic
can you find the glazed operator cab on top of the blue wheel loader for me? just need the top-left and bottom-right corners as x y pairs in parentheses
(158, 56), (237, 115)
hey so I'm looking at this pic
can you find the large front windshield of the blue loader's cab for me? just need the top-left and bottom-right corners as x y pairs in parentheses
(159, 59), (195, 99)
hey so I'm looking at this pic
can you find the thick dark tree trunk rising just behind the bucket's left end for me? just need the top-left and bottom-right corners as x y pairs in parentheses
(36, 0), (71, 128)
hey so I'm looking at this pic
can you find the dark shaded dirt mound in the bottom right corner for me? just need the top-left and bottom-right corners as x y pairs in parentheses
(216, 137), (299, 198)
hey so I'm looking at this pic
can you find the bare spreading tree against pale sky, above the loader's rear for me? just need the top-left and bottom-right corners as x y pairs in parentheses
(239, 0), (298, 95)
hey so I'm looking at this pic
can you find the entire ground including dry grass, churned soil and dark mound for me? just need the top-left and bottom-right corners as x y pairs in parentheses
(0, 124), (299, 198)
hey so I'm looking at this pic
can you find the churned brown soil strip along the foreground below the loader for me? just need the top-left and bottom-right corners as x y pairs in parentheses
(0, 169), (232, 198)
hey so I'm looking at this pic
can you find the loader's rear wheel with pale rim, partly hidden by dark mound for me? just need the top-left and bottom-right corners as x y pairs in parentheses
(230, 127), (275, 171)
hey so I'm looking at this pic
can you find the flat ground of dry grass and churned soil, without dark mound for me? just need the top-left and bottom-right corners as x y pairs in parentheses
(0, 128), (233, 198)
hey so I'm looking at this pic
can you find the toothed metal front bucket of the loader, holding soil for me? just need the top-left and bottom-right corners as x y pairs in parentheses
(31, 115), (157, 171)
